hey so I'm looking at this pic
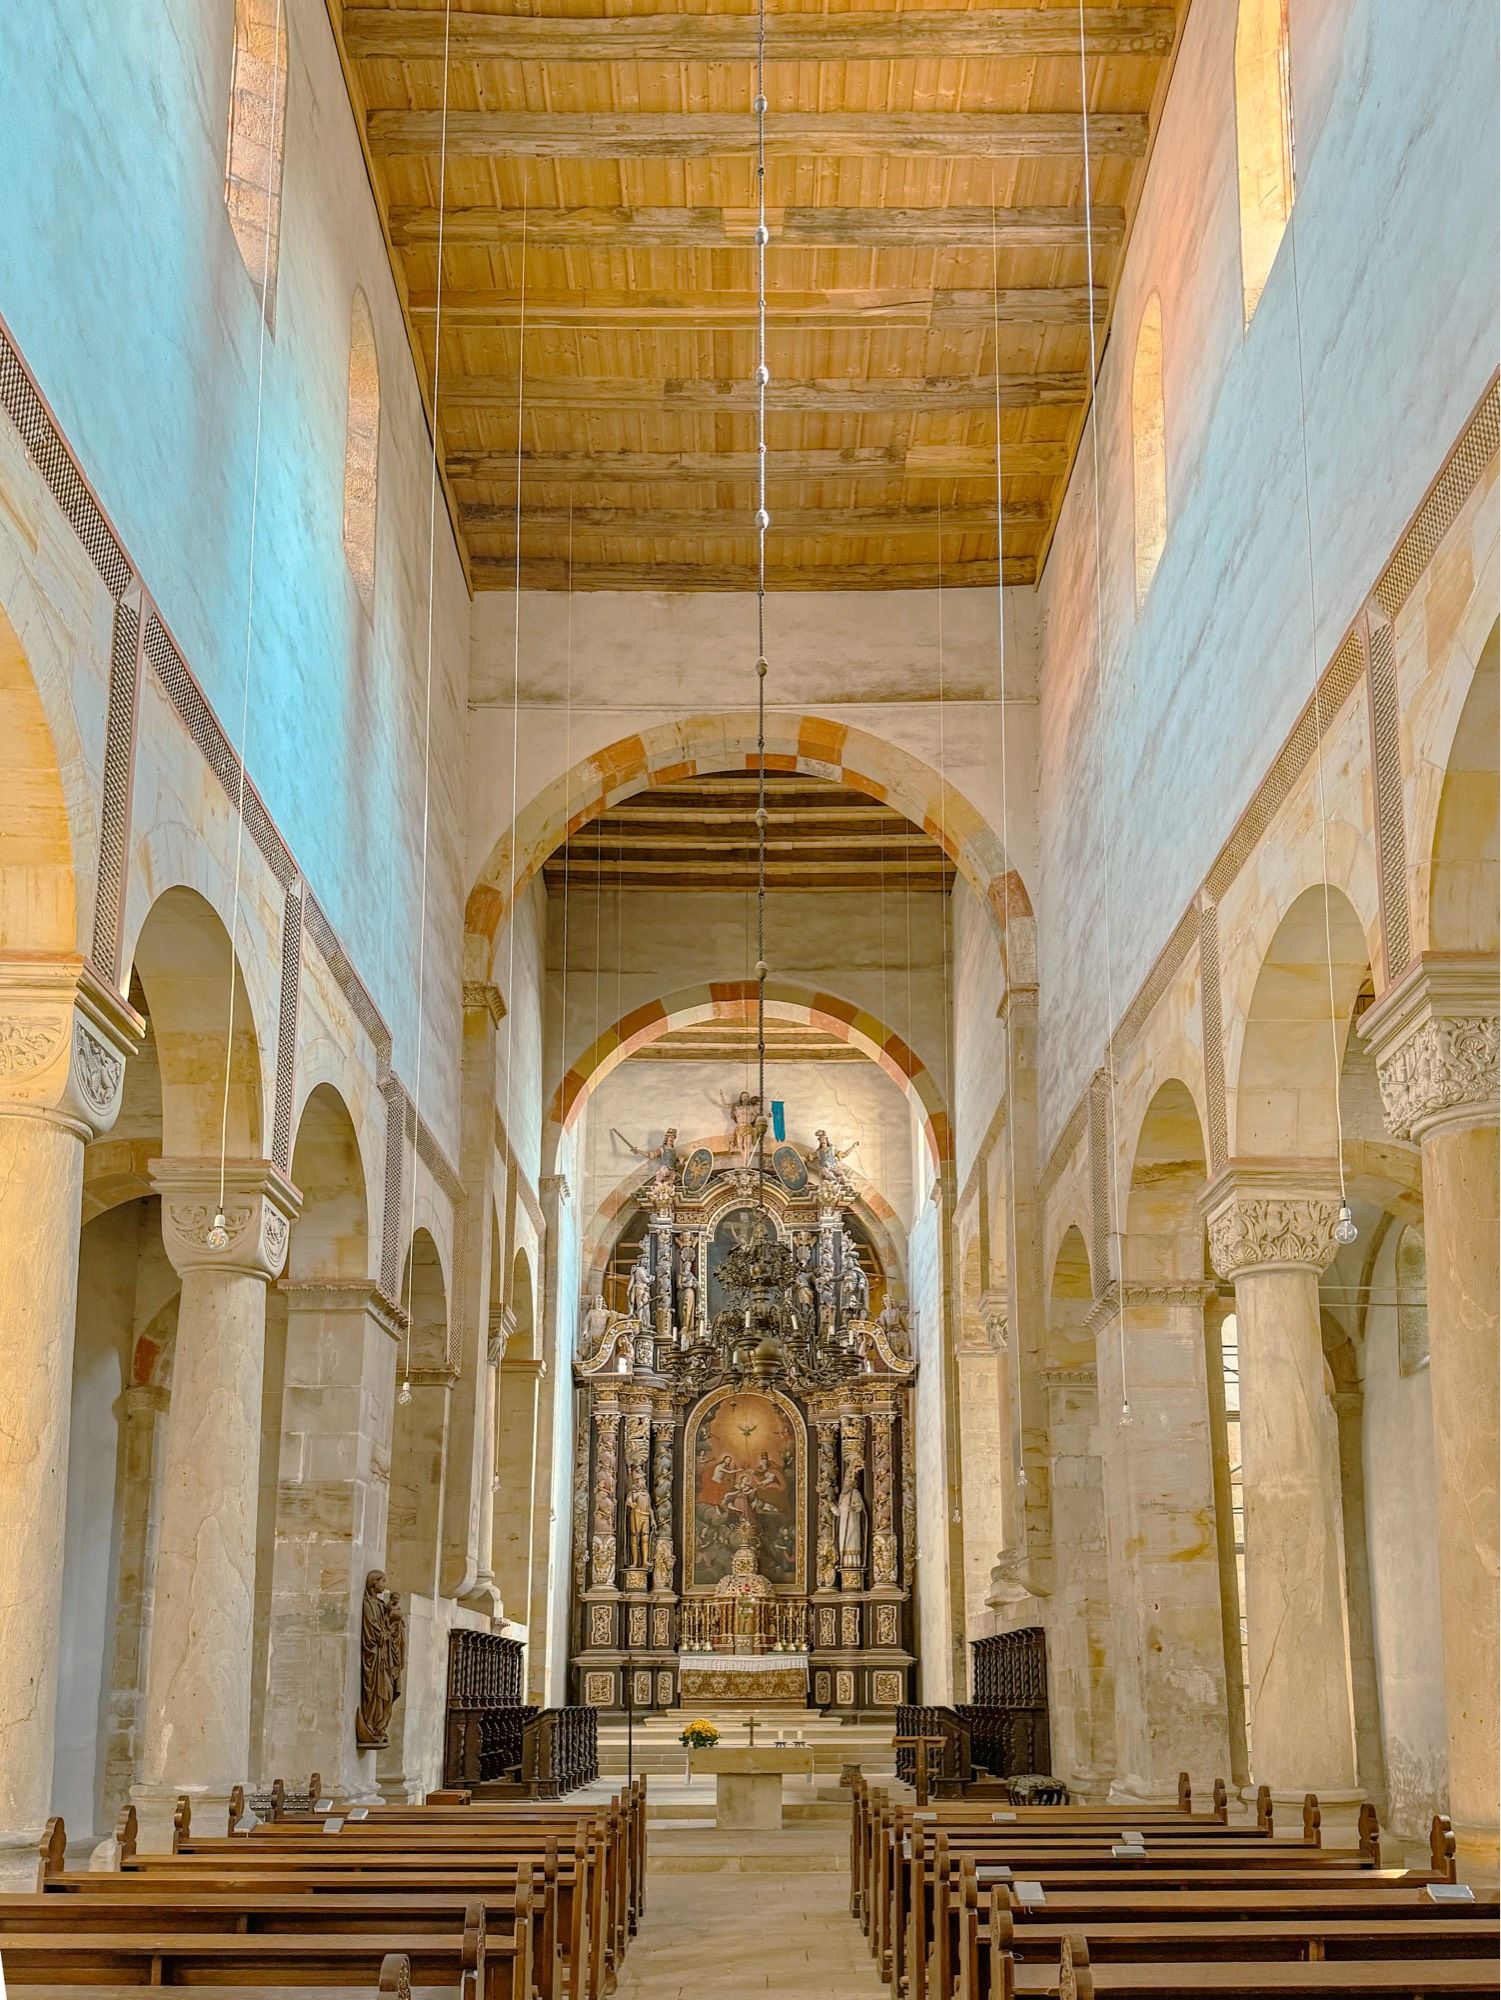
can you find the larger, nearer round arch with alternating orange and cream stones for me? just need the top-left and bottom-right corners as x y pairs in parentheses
(464, 710), (1037, 984)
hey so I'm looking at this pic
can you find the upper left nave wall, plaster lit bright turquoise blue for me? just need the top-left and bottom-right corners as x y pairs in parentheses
(0, 0), (468, 1112)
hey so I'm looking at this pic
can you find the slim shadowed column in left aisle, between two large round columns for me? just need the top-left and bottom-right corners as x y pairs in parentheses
(104, 1382), (168, 1826)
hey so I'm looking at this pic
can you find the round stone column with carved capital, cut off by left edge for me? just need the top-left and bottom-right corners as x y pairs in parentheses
(0, 960), (142, 1890)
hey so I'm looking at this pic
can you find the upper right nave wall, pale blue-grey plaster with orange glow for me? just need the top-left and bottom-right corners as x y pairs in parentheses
(1037, 0), (1497, 1152)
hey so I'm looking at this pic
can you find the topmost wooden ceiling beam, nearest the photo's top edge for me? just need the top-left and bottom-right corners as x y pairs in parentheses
(342, 6), (1173, 62)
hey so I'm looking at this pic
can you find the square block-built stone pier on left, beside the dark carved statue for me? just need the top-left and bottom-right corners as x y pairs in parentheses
(260, 1280), (400, 1804)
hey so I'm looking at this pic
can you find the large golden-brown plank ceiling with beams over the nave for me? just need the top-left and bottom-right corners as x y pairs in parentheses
(328, 0), (1189, 590)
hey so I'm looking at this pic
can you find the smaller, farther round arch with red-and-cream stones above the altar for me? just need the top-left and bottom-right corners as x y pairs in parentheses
(546, 980), (953, 1166)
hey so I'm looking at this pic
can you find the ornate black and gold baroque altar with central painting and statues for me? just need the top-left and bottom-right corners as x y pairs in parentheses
(570, 1120), (917, 1712)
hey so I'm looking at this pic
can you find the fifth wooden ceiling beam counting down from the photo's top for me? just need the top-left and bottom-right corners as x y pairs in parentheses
(442, 370), (1089, 416)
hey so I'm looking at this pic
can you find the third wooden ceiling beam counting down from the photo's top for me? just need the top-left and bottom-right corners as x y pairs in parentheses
(390, 206), (1125, 256)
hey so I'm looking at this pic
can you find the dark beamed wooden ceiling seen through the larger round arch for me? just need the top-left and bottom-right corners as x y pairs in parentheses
(542, 772), (953, 896)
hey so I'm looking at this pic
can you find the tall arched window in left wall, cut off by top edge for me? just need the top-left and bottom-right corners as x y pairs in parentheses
(224, 0), (286, 326)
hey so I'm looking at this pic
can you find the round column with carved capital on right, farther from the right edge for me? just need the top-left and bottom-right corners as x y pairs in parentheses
(1205, 1162), (1359, 1804)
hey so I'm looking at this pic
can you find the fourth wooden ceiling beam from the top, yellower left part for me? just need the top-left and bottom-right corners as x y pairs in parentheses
(410, 284), (1109, 332)
